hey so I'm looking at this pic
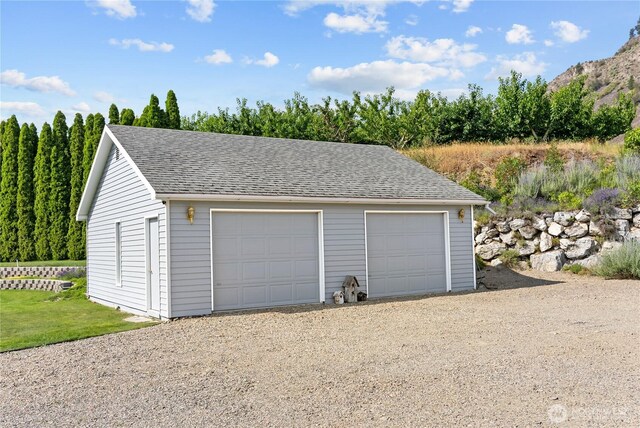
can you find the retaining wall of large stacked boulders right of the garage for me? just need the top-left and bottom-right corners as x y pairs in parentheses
(474, 206), (640, 272)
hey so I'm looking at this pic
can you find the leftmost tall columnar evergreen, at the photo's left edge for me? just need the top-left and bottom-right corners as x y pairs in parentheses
(0, 115), (20, 261)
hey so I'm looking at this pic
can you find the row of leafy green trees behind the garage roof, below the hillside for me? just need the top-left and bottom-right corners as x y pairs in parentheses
(181, 72), (635, 149)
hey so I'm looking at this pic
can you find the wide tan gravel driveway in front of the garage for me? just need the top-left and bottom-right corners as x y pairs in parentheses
(0, 272), (640, 427)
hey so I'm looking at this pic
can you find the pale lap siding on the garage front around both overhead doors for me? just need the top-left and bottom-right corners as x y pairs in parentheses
(169, 201), (474, 317)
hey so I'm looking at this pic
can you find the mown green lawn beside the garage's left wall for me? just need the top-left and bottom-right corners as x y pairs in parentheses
(0, 287), (155, 352)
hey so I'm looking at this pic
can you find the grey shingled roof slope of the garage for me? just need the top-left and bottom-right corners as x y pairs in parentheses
(108, 125), (485, 204)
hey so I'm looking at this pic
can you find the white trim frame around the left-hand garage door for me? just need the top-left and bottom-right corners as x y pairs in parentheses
(209, 208), (326, 313)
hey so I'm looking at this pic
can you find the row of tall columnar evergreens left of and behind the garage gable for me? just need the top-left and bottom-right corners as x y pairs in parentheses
(0, 91), (180, 261)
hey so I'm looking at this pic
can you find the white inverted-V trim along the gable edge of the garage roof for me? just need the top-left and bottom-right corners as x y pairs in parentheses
(76, 125), (156, 221)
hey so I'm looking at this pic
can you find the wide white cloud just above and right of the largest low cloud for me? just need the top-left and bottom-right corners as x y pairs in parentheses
(385, 36), (487, 67)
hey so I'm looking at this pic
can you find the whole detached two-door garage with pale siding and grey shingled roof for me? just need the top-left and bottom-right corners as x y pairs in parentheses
(77, 125), (486, 318)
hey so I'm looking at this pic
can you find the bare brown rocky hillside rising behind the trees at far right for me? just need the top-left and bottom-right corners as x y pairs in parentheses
(549, 35), (640, 128)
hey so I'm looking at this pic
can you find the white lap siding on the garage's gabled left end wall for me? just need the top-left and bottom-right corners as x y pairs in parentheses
(87, 145), (168, 317)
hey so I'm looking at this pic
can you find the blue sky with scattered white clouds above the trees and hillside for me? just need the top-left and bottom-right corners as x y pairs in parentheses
(0, 0), (640, 124)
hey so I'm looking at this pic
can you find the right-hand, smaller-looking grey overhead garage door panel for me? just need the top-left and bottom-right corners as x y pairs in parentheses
(367, 213), (447, 297)
